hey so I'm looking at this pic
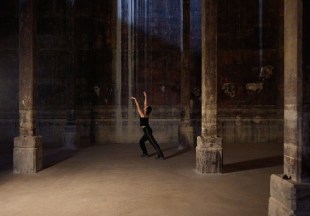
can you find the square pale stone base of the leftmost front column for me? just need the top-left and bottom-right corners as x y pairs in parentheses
(13, 136), (43, 174)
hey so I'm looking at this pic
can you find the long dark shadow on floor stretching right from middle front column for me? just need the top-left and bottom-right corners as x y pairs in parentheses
(223, 155), (283, 173)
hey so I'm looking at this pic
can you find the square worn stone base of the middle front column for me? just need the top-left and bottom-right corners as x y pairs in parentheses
(196, 136), (223, 174)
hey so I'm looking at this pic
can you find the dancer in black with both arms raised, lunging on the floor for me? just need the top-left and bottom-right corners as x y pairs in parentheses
(131, 91), (165, 160)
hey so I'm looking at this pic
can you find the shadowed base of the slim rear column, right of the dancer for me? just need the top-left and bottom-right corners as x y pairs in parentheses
(178, 125), (195, 150)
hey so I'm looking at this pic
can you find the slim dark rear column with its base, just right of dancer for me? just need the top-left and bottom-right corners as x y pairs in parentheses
(179, 0), (194, 150)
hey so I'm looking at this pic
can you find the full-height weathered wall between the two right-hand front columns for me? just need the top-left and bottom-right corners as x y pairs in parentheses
(218, 0), (283, 143)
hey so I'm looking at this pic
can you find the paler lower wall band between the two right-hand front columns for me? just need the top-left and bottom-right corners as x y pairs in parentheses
(218, 107), (283, 145)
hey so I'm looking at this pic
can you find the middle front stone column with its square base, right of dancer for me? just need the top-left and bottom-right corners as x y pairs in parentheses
(196, 0), (223, 173)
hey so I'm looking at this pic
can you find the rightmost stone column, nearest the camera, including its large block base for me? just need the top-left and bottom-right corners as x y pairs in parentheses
(269, 0), (310, 216)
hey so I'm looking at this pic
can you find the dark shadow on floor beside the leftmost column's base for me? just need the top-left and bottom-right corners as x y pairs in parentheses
(43, 148), (77, 169)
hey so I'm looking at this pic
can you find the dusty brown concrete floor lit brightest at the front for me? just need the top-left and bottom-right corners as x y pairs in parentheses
(0, 144), (282, 216)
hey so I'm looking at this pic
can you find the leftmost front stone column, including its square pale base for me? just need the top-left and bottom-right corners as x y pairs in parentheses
(13, 0), (42, 173)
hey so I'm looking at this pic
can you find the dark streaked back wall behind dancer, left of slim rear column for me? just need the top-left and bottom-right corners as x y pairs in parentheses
(0, 0), (186, 148)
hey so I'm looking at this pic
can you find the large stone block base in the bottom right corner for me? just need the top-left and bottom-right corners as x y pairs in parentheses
(268, 175), (310, 216)
